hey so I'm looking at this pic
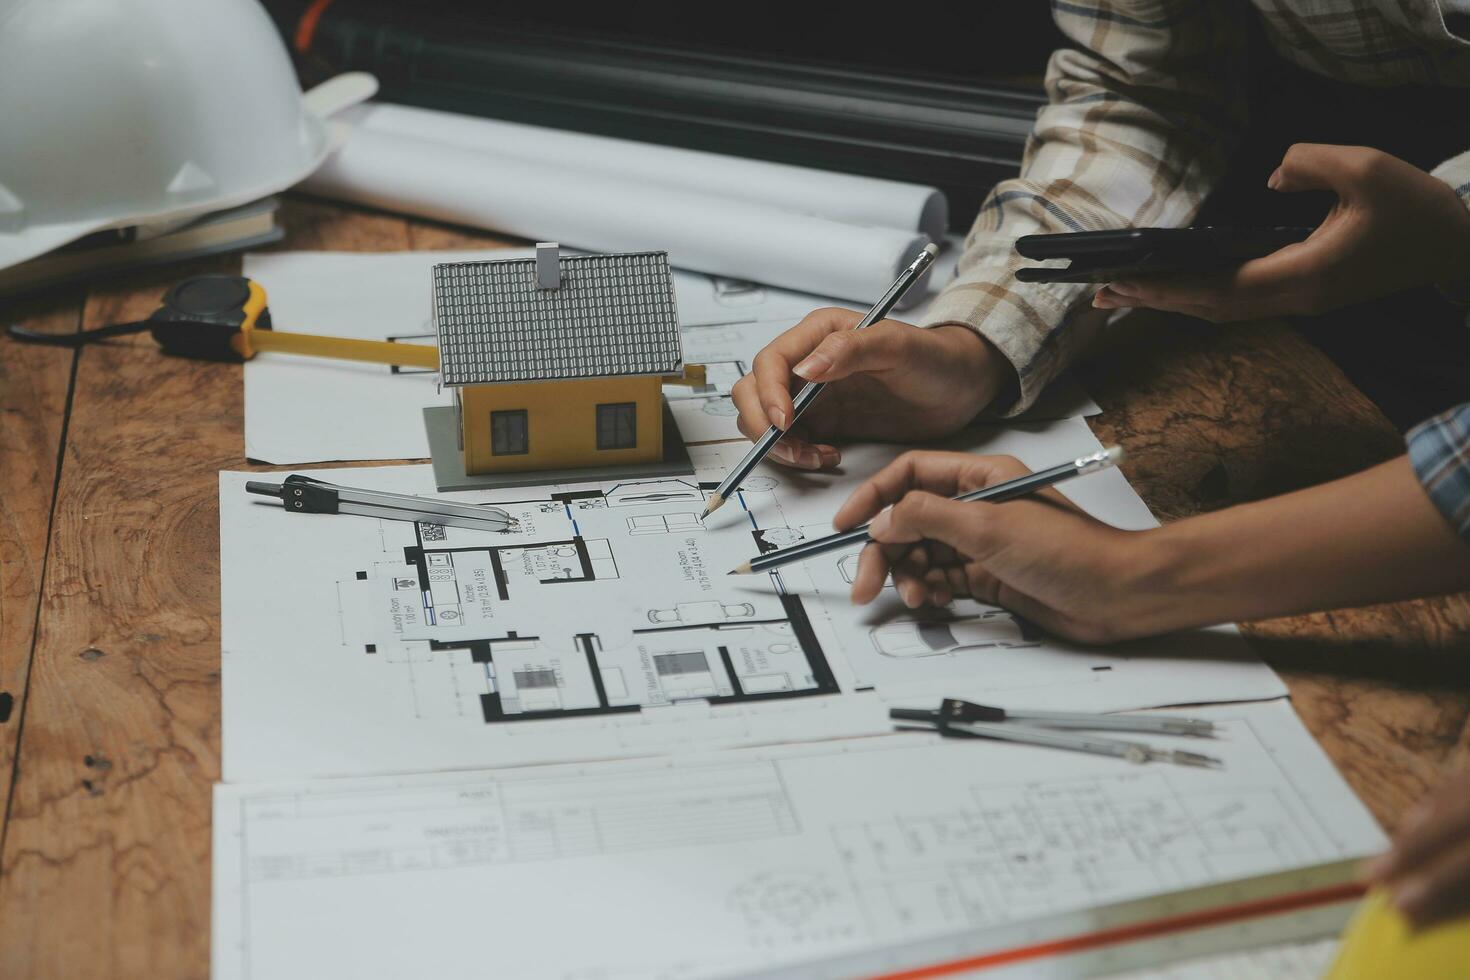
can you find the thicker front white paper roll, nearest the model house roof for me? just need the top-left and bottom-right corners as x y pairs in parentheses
(300, 129), (928, 303)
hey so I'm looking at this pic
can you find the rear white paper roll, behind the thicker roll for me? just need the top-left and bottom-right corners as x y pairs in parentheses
(338, 103), (950, 242)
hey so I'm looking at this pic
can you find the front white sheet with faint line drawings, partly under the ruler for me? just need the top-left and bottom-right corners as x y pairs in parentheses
(213, 702), (1386, 980)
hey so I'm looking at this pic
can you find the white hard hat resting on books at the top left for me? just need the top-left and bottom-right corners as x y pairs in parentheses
(0, 0), (376, 269)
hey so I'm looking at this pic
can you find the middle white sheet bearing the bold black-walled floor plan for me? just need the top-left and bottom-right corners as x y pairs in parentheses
(221, 420), (1285, 782)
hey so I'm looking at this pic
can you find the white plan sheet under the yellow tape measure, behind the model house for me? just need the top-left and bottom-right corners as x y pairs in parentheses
(244, 248), (1100, 464)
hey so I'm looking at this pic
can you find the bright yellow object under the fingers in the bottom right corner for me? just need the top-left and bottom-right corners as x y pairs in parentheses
(1324, 890), (1470, 980)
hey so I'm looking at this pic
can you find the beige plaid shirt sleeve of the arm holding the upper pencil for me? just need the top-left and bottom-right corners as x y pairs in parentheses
(925, 0), (1247, 414)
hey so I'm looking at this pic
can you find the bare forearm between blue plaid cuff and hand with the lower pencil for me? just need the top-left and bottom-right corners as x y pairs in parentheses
(1141, 457), (1470, 632)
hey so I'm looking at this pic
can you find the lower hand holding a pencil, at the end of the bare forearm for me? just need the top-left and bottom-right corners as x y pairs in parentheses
(832, 453), (1177, 642)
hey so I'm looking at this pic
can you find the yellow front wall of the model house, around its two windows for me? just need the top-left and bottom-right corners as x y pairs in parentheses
(460, 378), (663, 475)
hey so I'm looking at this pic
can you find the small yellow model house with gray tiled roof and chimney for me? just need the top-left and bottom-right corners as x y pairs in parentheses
(434, 244), (699, 475)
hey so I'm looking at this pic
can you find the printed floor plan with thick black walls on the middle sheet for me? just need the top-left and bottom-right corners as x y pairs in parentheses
(343, 479), (836, 721)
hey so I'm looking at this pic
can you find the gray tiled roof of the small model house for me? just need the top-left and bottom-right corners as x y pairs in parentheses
(434, 251), (684, 385)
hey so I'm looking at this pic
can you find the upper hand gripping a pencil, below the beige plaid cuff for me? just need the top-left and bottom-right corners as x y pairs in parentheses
(731, 309), (1011, 470)
